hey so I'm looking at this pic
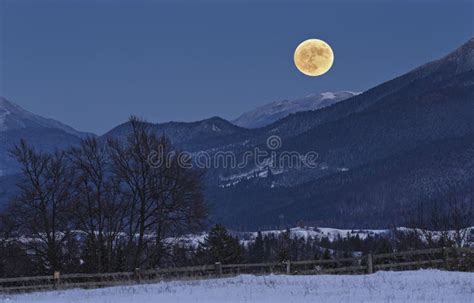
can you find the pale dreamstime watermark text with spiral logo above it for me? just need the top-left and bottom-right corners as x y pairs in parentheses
(148, 135), (320, 169)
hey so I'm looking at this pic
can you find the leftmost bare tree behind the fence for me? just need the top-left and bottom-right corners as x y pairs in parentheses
(8, 140), (71, 271)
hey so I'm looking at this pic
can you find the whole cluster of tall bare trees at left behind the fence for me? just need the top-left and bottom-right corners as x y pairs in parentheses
(0, 117), (207, 275)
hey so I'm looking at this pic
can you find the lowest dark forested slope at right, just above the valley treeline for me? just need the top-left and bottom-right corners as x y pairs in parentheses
(208, 134), (474, 229)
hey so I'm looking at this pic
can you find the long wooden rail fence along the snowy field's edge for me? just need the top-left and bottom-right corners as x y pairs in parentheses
(0, 248), (474, 293)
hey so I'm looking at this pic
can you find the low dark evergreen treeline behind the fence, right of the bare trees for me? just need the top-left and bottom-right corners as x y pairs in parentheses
(143, 224), (474, 266)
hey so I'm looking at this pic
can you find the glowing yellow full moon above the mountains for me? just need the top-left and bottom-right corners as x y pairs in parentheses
(294, 39), (334, 77)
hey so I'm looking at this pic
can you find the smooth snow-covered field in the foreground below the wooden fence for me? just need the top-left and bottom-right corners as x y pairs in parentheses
(0, 270), (474, 303)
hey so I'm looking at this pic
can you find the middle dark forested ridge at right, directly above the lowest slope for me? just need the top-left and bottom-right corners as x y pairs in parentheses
(285, 71), (474, 168)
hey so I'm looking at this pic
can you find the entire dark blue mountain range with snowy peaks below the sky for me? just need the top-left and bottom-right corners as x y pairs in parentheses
(0, 39), (474, 230)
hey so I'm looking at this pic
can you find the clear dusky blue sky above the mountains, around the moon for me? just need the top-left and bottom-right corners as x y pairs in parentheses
(0, 0), (474, 134)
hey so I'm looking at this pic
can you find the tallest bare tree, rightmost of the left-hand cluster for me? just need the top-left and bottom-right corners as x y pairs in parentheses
(109, 117), (206, 267)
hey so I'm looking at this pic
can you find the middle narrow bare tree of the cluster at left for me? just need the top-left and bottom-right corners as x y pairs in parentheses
(68, 137), (127, 272)
